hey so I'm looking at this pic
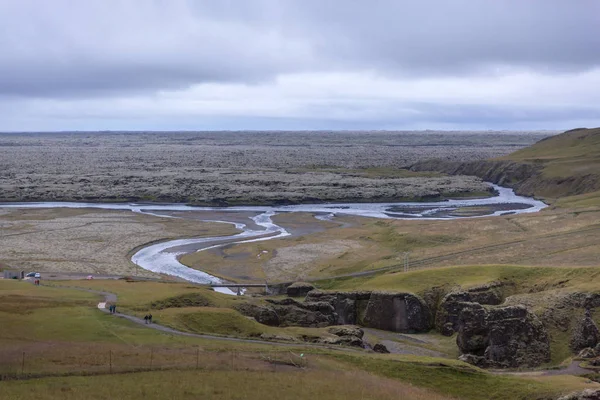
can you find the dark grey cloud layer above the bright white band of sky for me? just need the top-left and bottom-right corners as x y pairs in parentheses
(0, 0), (600, 97)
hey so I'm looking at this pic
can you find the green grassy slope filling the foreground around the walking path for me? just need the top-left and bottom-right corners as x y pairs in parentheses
(0, 271), (593, 399)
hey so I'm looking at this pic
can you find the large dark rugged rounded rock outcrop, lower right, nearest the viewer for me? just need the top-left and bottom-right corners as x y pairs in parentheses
(456, 303), (550, 368)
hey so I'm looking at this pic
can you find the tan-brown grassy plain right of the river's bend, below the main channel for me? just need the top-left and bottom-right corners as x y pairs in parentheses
(181, 208), (600, 282)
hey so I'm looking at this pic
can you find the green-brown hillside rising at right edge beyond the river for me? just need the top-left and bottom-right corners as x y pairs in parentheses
(411, 128), (600, 207)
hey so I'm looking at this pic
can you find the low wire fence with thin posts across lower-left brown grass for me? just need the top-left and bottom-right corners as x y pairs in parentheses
(0, 344), (308, 381)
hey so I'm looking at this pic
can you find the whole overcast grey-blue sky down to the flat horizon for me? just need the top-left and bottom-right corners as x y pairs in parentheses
(0, 0), (600, 131)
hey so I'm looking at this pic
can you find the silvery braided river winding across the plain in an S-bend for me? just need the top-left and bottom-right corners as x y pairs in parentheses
(0, 185), (546, 294)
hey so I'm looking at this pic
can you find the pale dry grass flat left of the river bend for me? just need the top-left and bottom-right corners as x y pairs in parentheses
(0, 209), (236, 276)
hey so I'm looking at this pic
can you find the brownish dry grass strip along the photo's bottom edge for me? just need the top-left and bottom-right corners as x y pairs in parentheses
(3, 370), (449, 400)
